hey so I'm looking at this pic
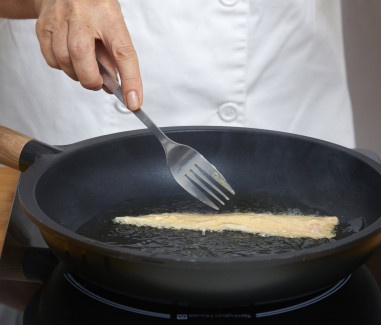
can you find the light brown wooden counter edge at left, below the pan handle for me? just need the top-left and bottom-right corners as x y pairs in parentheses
(0, 167), (20, 257)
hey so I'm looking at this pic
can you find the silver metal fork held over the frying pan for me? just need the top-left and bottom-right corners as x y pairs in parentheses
(97, 60), (235, 210)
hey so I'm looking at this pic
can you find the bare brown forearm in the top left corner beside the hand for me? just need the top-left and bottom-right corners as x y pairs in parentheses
(0, 0), (37, 19)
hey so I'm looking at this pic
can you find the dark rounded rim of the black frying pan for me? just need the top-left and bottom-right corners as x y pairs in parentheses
(18, 126), (381, 265)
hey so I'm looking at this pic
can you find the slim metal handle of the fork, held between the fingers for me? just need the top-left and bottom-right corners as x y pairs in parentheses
(97, 59), (173, 151)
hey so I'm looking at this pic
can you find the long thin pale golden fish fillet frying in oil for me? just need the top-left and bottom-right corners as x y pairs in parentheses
(114, 213), (339, 239)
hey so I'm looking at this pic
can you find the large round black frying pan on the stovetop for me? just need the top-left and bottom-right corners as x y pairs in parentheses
(0, 127), (381, 307)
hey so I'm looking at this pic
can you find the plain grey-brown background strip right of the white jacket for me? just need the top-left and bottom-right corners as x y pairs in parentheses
(342, 0), (381, 155)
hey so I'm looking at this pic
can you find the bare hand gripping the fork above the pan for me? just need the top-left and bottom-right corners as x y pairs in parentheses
(35, 0), (143, 110)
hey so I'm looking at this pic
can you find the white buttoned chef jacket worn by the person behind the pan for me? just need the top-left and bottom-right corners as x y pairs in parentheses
(0, 0), (354, 147)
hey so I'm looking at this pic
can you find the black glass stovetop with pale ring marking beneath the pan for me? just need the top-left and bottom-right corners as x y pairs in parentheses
(24, 264), (381, 325)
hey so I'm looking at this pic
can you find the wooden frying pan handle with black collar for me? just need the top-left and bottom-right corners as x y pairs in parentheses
(0, 124), (62, 172)
